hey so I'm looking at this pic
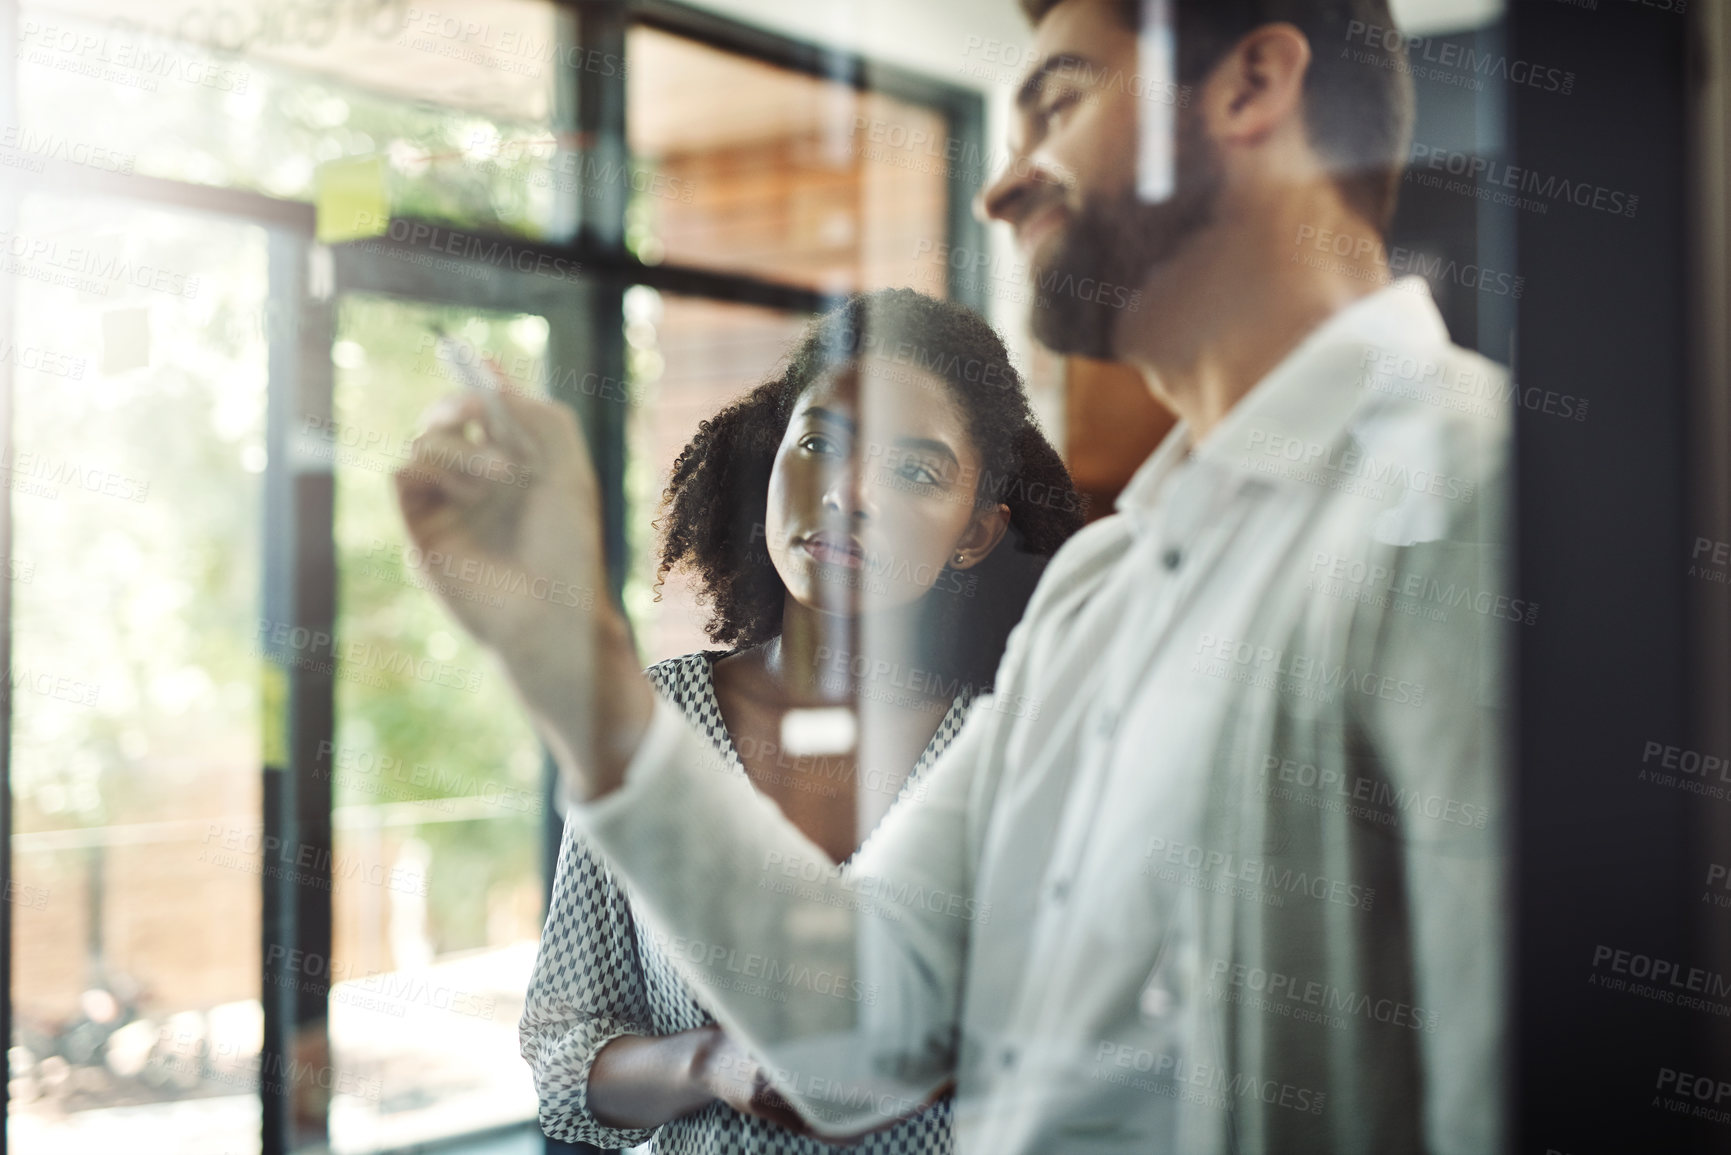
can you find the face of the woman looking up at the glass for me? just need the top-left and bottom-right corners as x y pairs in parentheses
(763, 357), (1009, 615)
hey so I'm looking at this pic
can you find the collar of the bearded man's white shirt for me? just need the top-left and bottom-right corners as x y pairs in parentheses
(1116, 277), (1449, 513)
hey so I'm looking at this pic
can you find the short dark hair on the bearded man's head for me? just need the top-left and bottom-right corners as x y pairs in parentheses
(1021, 0), (1412, 232)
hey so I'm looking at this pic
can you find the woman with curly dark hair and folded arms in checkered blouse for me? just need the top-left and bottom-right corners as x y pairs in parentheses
(521, 289), (1082, 1155)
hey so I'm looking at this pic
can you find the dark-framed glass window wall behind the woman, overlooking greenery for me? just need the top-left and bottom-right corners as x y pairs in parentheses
(0, 0), (978, 1155)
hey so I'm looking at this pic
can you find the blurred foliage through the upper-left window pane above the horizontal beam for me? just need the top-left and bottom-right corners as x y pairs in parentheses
(17, 12), (569, 236)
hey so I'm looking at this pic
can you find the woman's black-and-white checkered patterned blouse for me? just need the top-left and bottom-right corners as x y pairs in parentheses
(519, 653), (973, 1155)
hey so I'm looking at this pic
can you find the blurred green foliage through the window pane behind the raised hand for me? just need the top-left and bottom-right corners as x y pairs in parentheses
(331, 298), (547, 951)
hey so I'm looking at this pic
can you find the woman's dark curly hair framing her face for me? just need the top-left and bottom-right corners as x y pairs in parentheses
(658, 289), (1084, 689)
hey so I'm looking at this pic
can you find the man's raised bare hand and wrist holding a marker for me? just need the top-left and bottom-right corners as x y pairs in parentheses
(395, 393), (653, 798)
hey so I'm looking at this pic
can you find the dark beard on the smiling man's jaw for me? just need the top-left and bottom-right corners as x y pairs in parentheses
(1030, 114), (1220, 360)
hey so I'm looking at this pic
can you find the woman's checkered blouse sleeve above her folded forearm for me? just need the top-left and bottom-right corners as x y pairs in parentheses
(519, 823), (654, 1150)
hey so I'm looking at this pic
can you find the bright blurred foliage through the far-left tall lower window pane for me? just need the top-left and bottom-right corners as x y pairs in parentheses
(0, 194), (267, 1025)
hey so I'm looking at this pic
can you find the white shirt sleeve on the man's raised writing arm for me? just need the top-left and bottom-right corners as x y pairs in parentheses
(571, 685), (997, 1136)
